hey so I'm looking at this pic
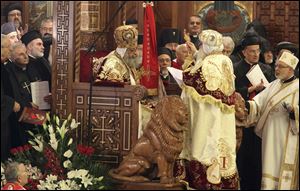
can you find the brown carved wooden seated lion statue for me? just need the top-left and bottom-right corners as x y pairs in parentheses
(109, 96), (189, 184)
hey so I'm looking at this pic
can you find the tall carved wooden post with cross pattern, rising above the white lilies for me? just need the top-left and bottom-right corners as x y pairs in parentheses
(52, 1), (74, 118)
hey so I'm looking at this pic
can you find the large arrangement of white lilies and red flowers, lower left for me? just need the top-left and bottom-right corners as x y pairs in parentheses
(1, 113), (106, 190)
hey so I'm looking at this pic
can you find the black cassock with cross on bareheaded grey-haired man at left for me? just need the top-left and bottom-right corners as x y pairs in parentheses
(1, 62), (41, 147)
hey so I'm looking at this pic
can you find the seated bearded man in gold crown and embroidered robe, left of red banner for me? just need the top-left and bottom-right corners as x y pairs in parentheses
(93, 25), (138, 85)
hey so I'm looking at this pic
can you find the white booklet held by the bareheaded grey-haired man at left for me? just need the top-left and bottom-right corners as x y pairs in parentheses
(30, 81), (50, 110)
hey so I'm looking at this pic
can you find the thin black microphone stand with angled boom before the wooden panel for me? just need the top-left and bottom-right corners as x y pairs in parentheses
(85, 1), (126, 146)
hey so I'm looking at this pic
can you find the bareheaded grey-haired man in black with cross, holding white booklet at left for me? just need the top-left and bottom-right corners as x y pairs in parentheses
(1, 42), (41, 147)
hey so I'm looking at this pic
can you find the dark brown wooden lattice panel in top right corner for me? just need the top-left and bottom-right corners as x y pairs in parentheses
(255, 1), (299, 46)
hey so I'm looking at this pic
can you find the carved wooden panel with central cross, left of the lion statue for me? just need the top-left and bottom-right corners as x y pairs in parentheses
(73, 83), (141, 164)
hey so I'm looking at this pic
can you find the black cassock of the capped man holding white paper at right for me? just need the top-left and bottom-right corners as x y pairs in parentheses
(234, 59), (275, 190)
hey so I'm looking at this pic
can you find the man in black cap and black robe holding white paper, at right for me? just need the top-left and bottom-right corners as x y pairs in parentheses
(234, 32), (275, 190)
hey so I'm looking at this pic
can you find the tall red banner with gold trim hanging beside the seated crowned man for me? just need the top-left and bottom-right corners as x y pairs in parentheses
(141, 3), (159, 95)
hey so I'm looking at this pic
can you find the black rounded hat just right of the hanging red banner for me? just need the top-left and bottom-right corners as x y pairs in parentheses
(159, 28), (182, 47)
